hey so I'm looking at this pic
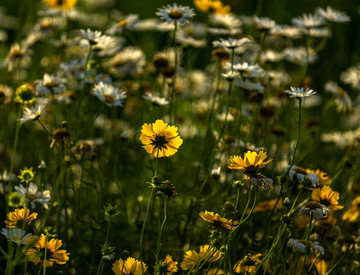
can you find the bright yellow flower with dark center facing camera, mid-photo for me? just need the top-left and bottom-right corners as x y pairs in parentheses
(140, 119), (183, 158)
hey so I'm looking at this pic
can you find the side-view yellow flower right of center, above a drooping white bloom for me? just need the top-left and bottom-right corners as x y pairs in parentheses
(228, 151), (272, 173)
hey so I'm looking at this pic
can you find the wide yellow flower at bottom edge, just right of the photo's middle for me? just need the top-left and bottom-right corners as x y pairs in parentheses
(180, 245), (222, 270)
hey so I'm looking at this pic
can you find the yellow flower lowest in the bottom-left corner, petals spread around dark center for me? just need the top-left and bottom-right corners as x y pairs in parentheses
(24, 234), (70, 266)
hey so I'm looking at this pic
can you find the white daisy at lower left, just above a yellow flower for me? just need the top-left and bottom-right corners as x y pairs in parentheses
(14, 182), (50, 209)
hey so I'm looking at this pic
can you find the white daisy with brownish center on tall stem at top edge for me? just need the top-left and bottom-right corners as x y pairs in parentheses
(155, 3), (195, 24)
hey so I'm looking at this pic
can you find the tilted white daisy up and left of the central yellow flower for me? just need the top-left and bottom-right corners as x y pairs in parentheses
(92, 82), (126, 107)
